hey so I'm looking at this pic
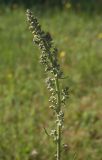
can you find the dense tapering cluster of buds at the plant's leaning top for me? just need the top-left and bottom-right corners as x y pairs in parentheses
(27, 10), (62, 77)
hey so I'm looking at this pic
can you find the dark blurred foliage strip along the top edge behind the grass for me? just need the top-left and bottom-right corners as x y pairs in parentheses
(0, 0), (102, 12)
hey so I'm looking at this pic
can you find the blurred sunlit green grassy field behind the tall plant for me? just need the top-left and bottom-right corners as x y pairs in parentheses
(0, 8), (102, 160)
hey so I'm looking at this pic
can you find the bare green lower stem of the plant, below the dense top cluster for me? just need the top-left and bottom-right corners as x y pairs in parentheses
(55, 77), (61, 160)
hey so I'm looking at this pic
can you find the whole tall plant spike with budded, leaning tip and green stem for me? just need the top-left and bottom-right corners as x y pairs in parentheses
(27, 10), (69, 160)
